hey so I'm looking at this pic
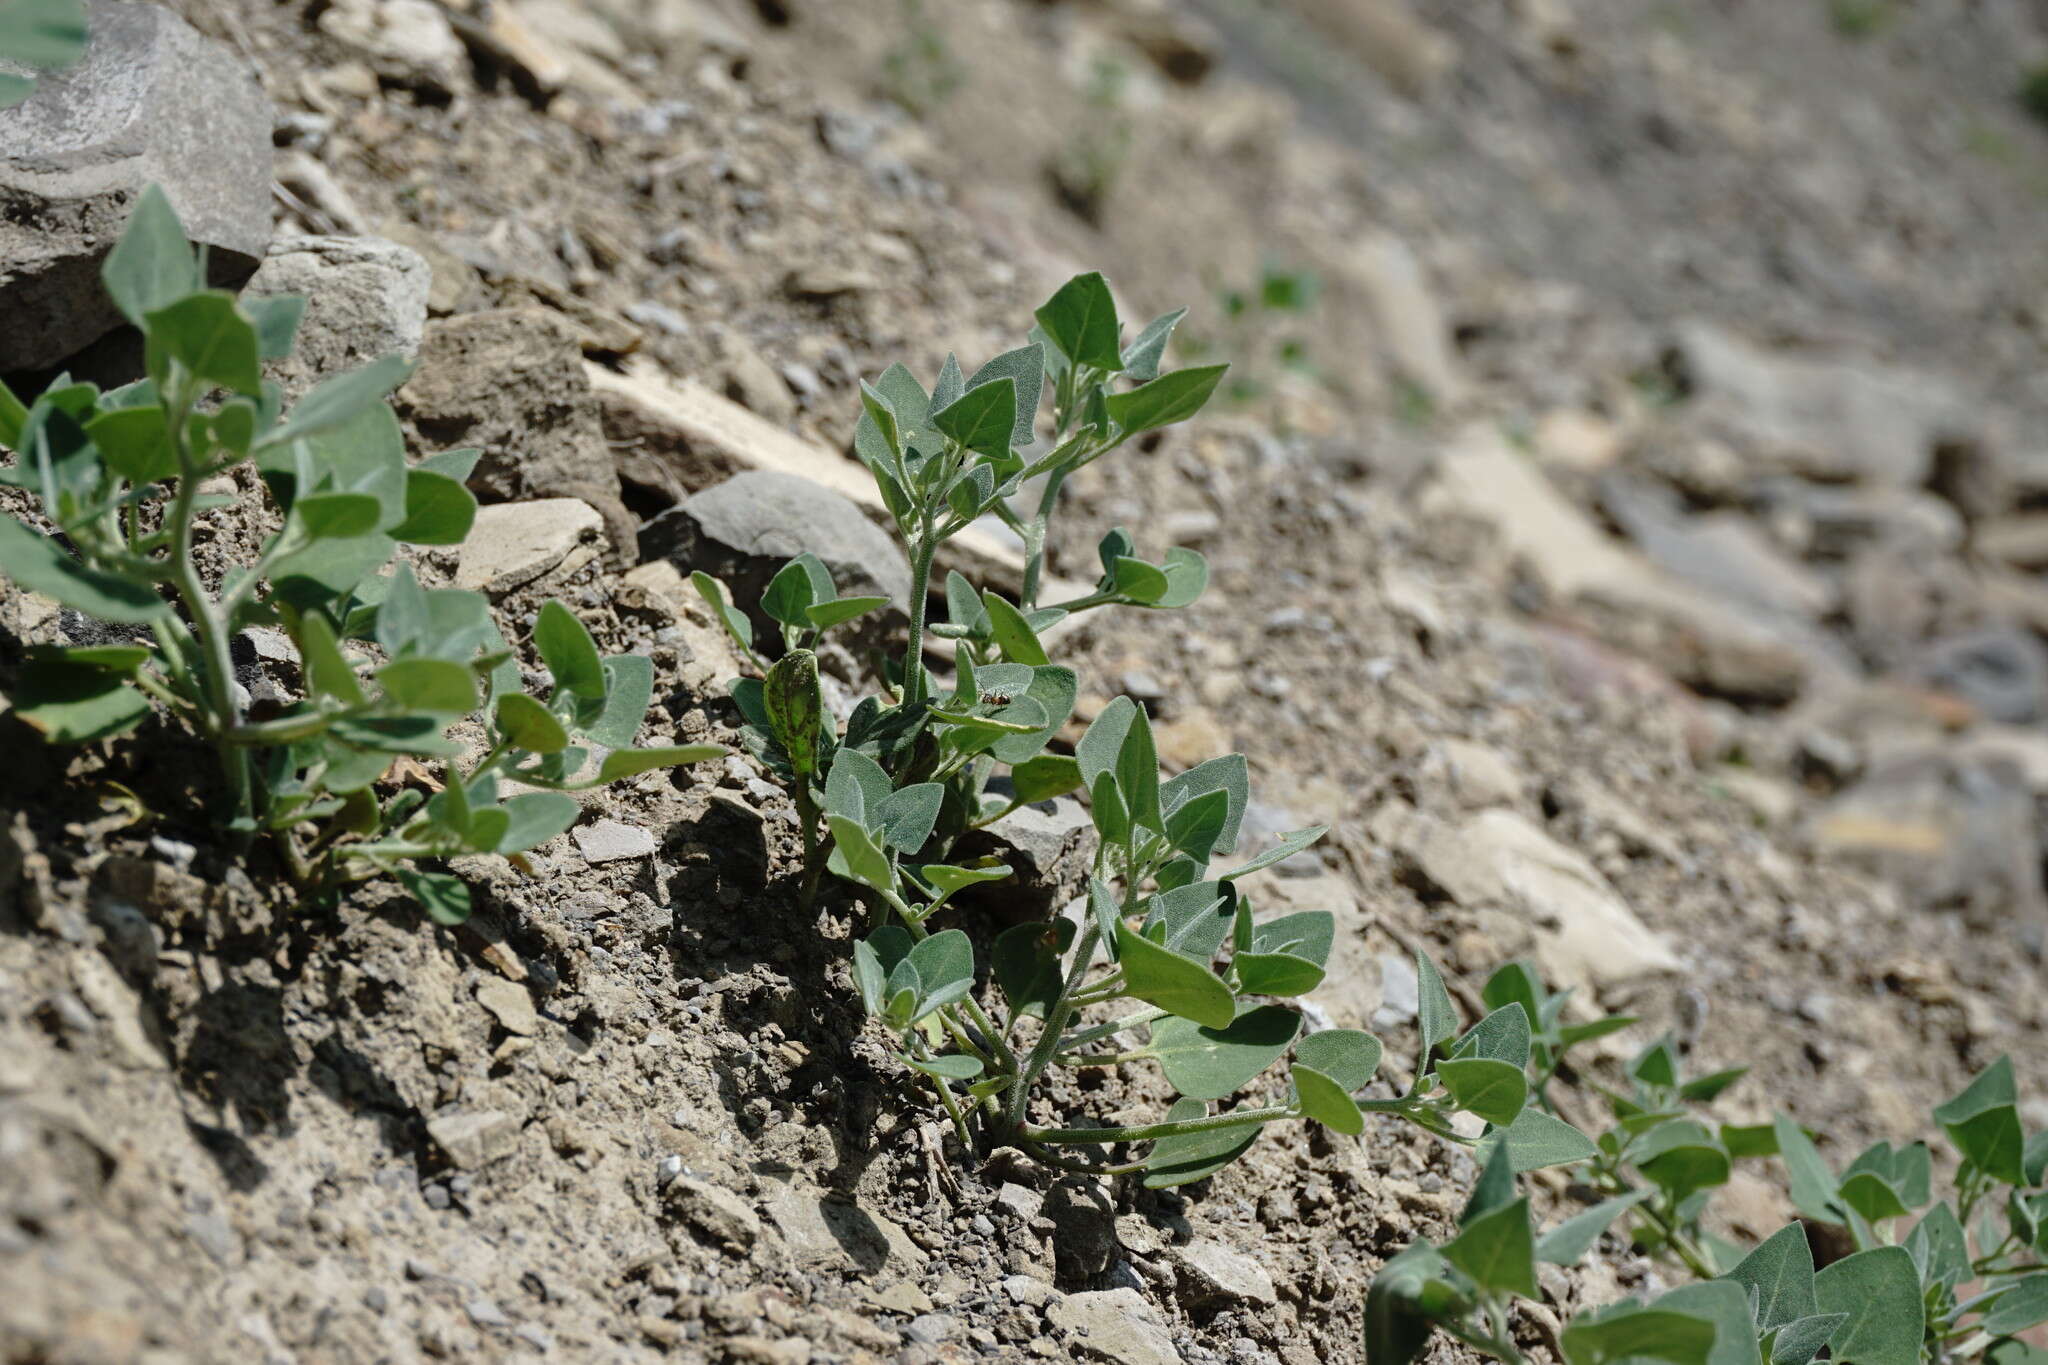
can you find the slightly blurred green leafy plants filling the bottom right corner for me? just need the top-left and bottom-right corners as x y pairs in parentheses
(1366, 964), (2048, 1365)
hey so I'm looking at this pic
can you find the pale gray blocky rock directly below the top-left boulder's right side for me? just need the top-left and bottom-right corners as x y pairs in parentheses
(242, 237), (434, 399)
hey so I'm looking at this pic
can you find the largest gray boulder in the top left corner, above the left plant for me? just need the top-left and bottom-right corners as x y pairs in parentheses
(0, 0), (272, 372)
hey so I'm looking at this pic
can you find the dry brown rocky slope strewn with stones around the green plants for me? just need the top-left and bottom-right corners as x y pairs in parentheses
(0, 0), (2048, 1365)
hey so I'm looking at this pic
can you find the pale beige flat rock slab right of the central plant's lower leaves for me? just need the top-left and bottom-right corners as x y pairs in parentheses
(1401, 808), (1683, 990)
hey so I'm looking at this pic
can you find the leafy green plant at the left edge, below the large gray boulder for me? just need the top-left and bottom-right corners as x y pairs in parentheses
(0, 188), (723, 921)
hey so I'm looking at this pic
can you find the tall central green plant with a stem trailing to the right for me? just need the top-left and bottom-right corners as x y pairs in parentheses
(696, 274), (1593, 1187)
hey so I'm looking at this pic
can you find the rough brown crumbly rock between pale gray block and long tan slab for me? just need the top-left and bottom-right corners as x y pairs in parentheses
(397, 309), (623, 517)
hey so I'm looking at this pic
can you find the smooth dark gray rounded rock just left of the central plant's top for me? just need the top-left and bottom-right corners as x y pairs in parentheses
(641, 471), (909, 606)
